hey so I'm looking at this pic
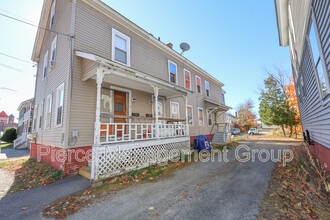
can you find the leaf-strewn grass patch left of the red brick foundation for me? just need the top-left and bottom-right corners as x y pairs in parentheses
(0, 158), (63, 194)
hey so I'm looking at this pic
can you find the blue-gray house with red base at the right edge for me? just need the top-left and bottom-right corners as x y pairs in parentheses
(275, 0), (330, 169)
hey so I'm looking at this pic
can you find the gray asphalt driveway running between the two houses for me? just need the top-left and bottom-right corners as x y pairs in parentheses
(69, 141), (298, 220)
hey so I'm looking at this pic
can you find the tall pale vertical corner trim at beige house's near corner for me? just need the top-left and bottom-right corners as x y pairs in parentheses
(64, 0), (77, 148)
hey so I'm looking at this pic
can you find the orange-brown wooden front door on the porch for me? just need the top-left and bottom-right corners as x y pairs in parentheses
(114, 91), (127, 136)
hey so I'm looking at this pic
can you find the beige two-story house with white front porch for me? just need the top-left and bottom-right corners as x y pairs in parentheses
(31, 0), (230, 179)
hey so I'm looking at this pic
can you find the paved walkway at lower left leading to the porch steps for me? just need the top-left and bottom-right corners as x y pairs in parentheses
(0, 173), (90, 220)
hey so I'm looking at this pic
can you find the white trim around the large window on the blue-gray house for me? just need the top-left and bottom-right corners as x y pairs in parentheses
(306, 10), (330, 106)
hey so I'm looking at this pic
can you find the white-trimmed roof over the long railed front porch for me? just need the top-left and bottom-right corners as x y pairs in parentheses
(76, 51), (193, 97)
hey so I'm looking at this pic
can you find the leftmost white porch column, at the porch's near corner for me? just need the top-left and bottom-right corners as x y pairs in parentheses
(94, 68), (104, 144)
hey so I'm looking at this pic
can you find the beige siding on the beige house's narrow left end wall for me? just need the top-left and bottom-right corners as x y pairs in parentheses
(35, 1), (72, 147)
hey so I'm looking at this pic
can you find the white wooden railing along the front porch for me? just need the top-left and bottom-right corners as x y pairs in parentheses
(100, 123), (188, 144)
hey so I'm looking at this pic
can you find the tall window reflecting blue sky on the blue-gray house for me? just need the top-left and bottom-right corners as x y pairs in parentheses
(309, 21), (330, 98)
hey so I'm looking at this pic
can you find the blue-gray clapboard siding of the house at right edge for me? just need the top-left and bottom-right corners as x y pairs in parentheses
(289, 0), (330, 148)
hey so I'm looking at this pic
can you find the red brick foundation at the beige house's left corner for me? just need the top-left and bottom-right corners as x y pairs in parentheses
(30, 143), (92, 176)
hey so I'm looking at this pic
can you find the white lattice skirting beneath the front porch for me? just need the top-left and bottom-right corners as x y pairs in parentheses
(91, 137), (190, 180)
